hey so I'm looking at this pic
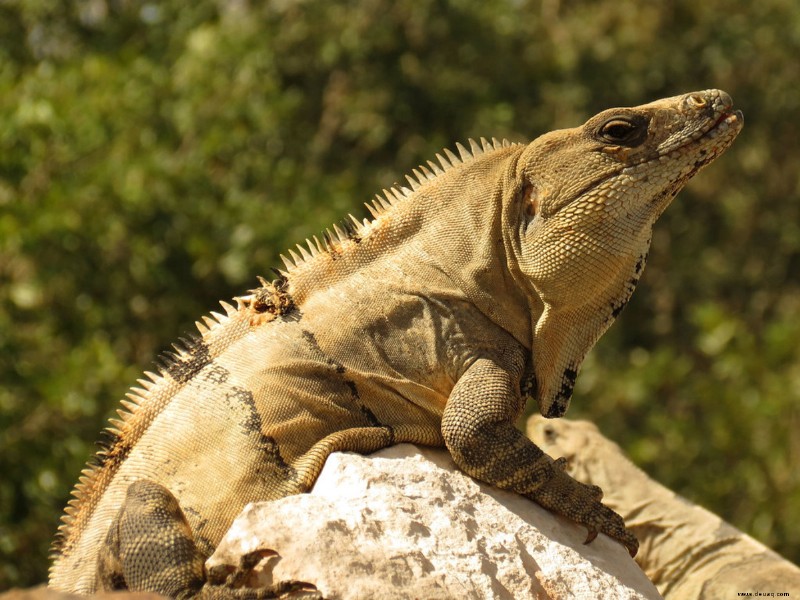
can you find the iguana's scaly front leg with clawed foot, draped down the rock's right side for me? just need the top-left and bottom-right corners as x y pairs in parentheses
(442, 356), (639, 556)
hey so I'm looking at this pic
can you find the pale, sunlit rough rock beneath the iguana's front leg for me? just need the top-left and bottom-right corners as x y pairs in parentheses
(207, 444), (660, 599)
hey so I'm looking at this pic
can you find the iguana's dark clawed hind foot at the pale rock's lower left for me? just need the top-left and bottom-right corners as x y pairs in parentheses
(201, 549), (324, 600)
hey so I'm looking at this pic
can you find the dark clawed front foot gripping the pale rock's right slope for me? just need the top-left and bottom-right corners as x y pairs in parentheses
(532, 458), (639, 556)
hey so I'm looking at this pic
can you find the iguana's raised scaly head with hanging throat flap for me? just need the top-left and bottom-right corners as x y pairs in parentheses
(514, 90), (743, 417)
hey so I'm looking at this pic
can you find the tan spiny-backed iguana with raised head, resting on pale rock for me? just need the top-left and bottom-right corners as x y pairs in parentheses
(50, 90), (743, 596)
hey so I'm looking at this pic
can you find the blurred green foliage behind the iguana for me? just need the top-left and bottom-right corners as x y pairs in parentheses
(0, 0), (800, 589)
